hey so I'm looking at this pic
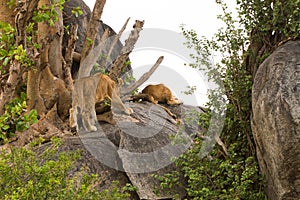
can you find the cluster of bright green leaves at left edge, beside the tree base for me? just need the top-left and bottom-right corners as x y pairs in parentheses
(0, 93), (38, 140)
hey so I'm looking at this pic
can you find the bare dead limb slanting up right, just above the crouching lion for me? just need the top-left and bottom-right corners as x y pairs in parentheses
(121, 56), (164, 96)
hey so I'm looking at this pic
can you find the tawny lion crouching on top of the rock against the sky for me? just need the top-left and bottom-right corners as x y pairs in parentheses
(142, 84), (182, 105)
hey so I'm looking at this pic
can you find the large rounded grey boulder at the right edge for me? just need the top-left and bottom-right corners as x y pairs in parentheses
(252, 41), (300, 200)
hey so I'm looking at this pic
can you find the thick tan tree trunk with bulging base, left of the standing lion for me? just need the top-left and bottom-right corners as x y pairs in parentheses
(27, 0), (63, 116)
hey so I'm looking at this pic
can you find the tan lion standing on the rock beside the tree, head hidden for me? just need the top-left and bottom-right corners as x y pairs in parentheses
(70, 73), (133, 131)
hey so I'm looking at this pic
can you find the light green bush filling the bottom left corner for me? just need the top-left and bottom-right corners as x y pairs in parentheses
(0, 139), (130, 200)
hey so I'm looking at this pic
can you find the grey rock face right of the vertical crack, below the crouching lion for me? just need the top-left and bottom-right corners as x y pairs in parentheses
(118, 103), (197, 199)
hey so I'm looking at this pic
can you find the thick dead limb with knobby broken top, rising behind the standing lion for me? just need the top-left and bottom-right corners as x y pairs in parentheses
(109, 20), (144, 81)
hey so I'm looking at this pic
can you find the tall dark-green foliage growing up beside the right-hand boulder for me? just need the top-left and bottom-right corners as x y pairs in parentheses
(157, 0), (300, 200)
